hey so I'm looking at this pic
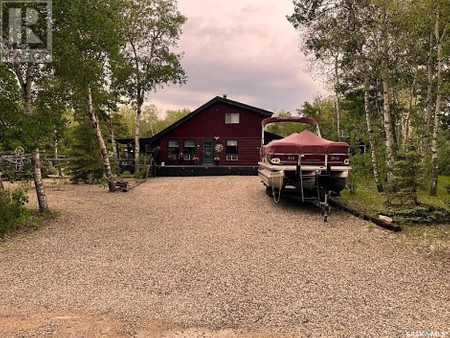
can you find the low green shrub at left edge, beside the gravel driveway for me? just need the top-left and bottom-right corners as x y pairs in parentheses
(0, 189), (29, 234)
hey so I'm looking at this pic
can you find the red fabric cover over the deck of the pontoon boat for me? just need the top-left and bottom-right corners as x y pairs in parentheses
(263, 130), (349, 155)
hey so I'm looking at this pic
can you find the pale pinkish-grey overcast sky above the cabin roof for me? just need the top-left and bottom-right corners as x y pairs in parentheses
(148, 0), (324, 116)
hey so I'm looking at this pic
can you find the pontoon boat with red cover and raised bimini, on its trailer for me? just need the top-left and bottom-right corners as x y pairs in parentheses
(258, 117), (351, 222)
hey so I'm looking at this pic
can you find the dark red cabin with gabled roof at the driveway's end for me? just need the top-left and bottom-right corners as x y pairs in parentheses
(151, 96), (272, 176)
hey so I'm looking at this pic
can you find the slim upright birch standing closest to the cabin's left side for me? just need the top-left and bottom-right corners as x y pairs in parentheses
(117, 0), (186, 174)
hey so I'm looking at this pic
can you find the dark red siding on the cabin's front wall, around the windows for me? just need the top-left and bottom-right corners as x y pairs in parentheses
(160, 102), (264, 166)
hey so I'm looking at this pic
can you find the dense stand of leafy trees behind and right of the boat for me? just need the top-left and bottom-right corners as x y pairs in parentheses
(288, 0), (450, 201)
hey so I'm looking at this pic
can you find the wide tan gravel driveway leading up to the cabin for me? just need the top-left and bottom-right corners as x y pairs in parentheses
(0, 177), (450, 337)
